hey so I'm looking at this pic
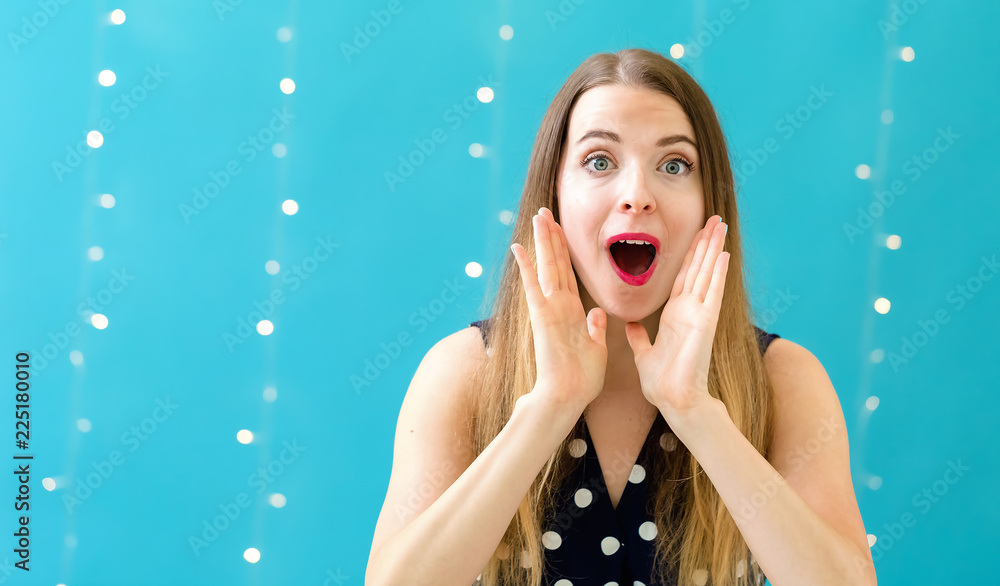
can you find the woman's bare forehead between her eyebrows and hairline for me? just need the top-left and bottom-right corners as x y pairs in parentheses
(567, 85), (694, 143)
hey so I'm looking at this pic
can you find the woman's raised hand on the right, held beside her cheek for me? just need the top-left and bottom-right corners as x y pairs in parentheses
(625, 215), (729, 425)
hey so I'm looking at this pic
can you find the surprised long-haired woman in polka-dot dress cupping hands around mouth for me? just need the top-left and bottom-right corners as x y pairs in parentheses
(365, 49), (876, 586)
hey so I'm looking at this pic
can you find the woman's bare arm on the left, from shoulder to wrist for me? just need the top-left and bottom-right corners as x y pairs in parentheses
(365, 328), (583, 586)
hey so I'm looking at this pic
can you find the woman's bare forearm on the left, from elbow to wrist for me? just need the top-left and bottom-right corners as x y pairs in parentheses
(365, 391), (583, 586)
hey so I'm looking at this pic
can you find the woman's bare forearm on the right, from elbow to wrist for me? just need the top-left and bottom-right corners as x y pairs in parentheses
(675, 398), (875, 586)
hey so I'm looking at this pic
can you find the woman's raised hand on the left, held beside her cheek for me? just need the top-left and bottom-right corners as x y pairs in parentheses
(511, 208), (608, 413)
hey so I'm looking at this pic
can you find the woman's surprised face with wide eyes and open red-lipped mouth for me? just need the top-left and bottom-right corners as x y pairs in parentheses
(556, 85), (705, 321)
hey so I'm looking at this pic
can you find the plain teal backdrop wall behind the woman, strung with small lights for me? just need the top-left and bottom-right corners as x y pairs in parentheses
(0, 0), (1000, 586)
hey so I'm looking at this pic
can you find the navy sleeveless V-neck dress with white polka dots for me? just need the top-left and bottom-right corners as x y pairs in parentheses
(469, 320), (780, 586)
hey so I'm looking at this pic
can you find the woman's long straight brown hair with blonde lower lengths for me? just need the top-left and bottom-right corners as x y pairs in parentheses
(470, 49), (772, 586)
